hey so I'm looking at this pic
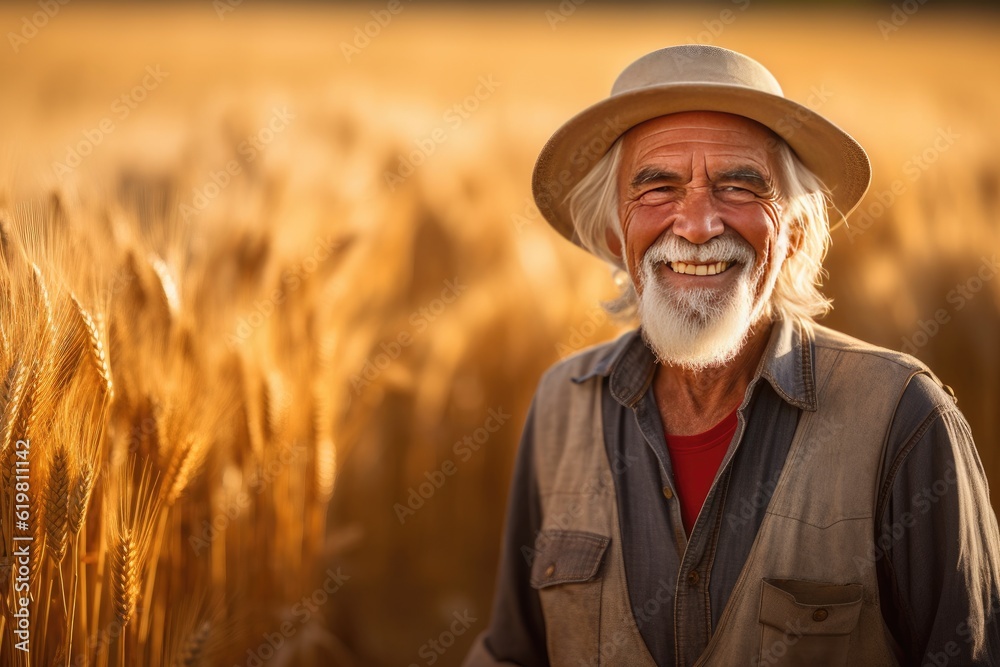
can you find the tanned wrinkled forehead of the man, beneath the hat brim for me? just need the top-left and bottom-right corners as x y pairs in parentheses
(622, 111), (780, 173)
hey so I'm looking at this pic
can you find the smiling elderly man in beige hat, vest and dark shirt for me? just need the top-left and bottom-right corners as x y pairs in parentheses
(467, 46), (1000, 666)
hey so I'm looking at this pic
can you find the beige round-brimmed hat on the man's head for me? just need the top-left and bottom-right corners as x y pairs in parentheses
(532, 44), (871, 245)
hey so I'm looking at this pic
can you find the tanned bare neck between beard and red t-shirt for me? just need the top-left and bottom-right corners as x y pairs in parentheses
(653, 321), (772, 435)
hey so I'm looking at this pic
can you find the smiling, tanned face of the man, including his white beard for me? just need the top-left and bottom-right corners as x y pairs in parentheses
(618, 112), (788, 369)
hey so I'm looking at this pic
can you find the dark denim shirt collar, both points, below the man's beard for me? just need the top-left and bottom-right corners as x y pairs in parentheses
(573, 320), (816, 412)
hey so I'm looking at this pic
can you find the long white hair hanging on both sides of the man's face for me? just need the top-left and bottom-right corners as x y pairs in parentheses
(566, 137), (831, 323)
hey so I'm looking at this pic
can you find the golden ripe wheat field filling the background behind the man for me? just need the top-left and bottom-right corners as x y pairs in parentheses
(0, 0), (1000, 667)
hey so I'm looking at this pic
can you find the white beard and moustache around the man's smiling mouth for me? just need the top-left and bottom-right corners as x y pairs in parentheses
(639, 229), (777, 371)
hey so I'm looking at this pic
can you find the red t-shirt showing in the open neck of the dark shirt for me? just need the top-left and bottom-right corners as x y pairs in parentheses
(667, 406), (739, 535)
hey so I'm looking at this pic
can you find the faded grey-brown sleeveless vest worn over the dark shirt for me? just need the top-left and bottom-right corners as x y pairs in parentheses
(467, 325), (933, 667)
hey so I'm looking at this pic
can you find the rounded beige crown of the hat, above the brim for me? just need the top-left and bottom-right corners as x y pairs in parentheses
(611, 44), (784, 97)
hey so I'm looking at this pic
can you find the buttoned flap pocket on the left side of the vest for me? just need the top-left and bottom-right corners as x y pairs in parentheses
(531, 530), (611, 665)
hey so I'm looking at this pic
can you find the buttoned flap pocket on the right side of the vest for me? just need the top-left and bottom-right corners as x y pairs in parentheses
(757, 579), (864, 667)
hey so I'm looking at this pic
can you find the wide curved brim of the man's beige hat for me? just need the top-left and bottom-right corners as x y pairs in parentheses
(532, 83), (871, 245)
